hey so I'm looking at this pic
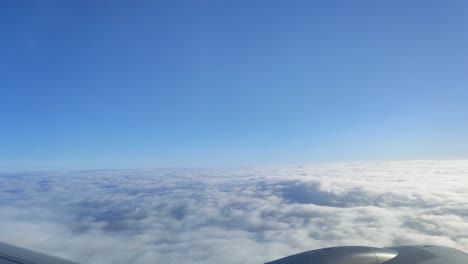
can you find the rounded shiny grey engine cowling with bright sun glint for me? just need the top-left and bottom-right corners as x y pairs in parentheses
(266, 245), (468, 264)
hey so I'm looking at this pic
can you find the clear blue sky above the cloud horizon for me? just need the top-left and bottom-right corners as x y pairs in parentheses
(0, 0), (468, 171)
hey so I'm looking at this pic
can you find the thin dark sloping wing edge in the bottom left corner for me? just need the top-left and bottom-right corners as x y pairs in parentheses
(0, 242), (78, 264)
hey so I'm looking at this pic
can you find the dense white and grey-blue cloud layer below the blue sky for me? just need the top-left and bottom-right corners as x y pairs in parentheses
(0, 161), (468, 264)
